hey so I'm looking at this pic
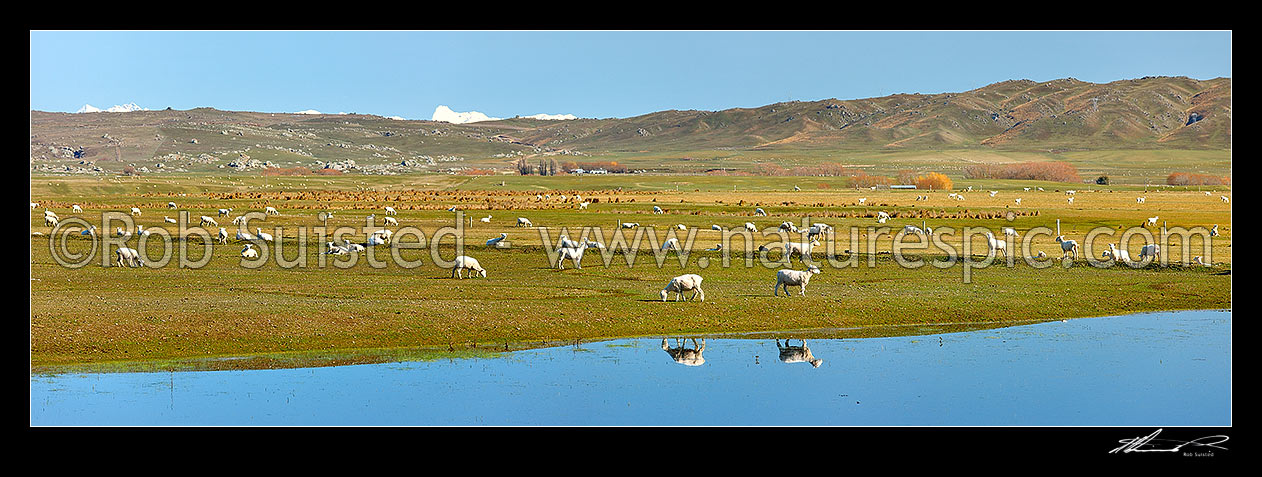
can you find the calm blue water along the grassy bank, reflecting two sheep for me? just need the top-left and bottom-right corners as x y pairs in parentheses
(30, 310), (1232, 427)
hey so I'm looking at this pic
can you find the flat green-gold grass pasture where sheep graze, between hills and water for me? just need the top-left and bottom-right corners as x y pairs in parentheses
(30, 174), (1232, 366)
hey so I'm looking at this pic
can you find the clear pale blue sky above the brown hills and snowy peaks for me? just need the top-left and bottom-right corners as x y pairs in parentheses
(30, 32), (1232, 119)
